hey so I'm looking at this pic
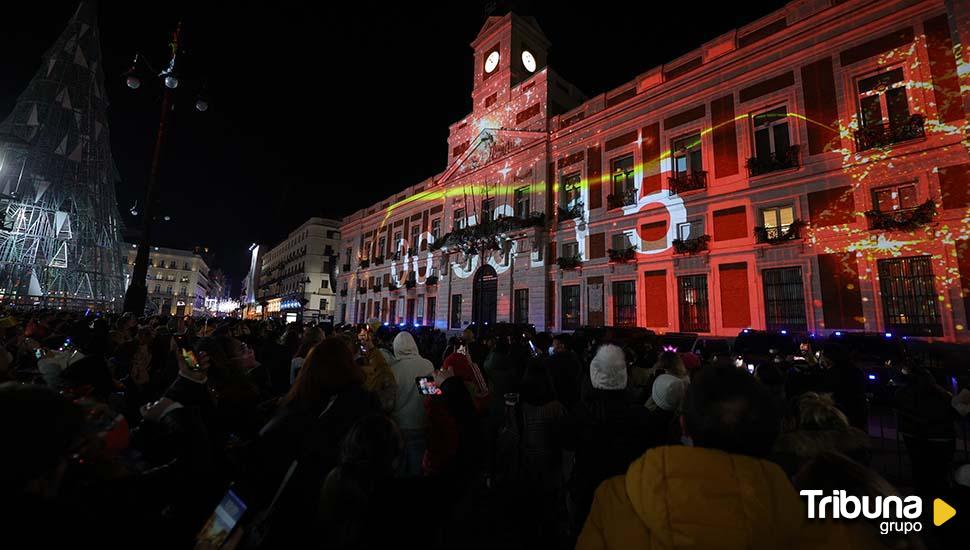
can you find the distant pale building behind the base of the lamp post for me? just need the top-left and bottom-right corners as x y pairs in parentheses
(125, 244), (210, 316)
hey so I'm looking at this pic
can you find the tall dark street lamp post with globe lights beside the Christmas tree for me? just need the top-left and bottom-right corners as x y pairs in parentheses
(123, 22), (209, 315)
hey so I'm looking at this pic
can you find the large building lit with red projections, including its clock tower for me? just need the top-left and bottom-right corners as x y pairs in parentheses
(337, 0), (970, 341)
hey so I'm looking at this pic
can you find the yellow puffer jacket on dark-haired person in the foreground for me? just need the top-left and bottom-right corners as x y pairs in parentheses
(576, 446), (864, 550)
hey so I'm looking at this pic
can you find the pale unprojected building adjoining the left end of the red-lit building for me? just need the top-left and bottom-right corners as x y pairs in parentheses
(258, 218), (341, 321)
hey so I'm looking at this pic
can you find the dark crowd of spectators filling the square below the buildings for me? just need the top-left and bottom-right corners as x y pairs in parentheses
(0, 311), (970, 549)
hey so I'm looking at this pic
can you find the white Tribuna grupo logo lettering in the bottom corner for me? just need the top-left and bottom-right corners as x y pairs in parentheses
(799, 489), (923, 535)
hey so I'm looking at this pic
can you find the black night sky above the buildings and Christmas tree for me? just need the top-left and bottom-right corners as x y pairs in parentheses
(0, 0), (785, 292)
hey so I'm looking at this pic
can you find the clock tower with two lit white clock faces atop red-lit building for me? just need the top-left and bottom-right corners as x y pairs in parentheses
(471, 12), (549, 113)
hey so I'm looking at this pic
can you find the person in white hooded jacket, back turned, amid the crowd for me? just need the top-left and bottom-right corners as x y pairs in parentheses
(391, 332), (434, 430)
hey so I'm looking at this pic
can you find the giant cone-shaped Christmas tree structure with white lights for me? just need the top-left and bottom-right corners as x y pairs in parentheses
(0, 2), (124, 309)
